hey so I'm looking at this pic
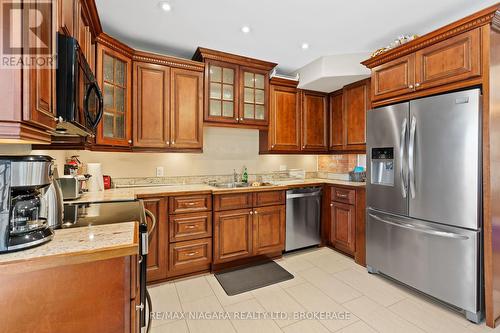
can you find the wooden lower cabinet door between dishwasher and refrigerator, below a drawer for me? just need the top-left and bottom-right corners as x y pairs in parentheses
(330, 202), (356, 255)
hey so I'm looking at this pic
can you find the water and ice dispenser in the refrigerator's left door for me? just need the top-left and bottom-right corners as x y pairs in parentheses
(370, 147), (394, 186)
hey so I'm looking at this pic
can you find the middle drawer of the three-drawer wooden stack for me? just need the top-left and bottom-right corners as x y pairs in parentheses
(169, 212), (212, 242)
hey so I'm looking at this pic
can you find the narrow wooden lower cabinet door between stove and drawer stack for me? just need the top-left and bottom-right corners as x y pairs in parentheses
(143, 198), (168, 282)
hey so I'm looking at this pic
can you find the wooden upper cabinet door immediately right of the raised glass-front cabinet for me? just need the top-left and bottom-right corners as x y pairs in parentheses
(259, 77), (301, 153)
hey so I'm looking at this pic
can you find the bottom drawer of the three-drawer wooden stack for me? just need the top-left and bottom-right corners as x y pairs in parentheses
(168, 238), (212, 276)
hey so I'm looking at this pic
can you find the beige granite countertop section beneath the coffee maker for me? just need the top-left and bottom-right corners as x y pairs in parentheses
(0, 222), (139, 275)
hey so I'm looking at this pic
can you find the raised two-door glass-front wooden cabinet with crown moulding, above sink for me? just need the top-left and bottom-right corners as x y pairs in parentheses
(193, 47), (276, 129)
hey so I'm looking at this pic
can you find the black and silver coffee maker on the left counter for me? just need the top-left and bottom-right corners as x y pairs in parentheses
(0, 156), (54, 253)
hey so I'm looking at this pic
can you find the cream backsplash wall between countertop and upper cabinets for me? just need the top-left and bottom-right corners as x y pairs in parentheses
(0, 127), (318, 178)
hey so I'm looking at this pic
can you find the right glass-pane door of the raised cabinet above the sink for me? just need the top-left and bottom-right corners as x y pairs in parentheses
(239, 68), (269, 125)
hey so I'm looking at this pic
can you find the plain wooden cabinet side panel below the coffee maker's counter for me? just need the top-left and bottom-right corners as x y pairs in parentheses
(0, 256), (140, 333)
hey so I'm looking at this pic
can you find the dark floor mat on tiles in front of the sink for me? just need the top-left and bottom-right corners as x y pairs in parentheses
(215, 261), (293, 296)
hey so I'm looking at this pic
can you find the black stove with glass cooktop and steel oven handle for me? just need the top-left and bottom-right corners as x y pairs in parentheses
(61, 200), (156, 331)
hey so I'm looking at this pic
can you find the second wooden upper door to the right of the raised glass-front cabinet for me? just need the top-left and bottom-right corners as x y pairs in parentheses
(302, 91), (328, 151)
